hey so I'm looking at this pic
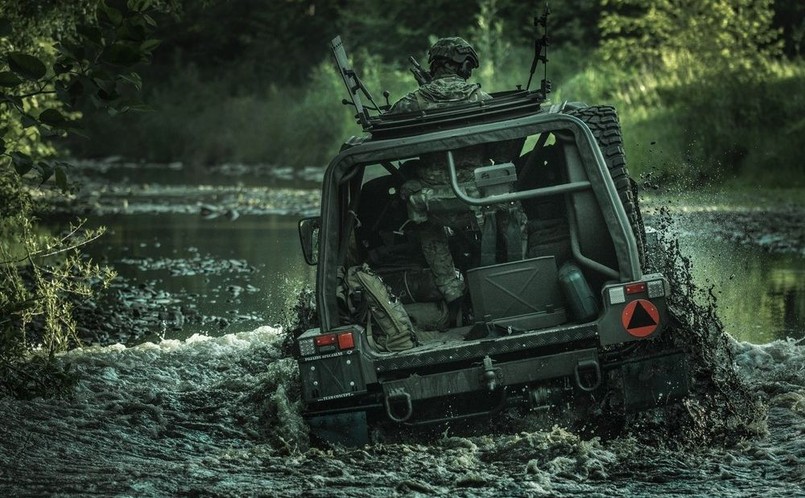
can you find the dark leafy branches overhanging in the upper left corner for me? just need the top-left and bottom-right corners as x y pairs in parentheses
(0, 0), (174, 190)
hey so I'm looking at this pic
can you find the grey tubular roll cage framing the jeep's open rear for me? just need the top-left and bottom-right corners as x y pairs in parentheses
(317, 112), (642, 330)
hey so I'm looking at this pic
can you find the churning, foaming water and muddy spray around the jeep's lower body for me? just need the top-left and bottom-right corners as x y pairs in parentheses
(0, 209), (805, 497)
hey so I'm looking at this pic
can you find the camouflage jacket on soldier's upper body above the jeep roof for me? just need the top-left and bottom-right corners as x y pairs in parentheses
(388, 75), (492, 114)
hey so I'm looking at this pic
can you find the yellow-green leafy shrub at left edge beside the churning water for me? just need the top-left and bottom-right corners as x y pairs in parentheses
(0, 170), (114, 397)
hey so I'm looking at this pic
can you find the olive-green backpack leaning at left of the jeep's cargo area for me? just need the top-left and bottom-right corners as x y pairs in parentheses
(336, 263), (418, 351)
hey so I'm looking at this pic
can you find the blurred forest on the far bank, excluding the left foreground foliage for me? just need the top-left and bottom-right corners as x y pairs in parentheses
(72, 0), (805, 186)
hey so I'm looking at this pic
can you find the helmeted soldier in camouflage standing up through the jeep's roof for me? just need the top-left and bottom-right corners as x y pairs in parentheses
(388, 37), (492, 303)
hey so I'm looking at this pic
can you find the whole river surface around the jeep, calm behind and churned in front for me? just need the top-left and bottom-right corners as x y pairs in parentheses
(0, 161), (805, 497)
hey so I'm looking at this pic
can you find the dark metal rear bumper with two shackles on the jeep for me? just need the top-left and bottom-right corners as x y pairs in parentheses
(298, 348), (689, 425)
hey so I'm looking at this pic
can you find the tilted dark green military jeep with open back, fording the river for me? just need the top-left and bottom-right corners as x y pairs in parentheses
(295, 33), (689, 444)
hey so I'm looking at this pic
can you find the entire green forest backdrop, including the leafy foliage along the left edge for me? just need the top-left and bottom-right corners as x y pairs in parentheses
(0, 0), (805, 394)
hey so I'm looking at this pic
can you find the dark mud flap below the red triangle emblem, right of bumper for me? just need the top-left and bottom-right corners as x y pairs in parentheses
(621, 352), (690, 412)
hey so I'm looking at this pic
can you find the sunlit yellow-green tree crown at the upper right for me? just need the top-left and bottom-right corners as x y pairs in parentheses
(600, 0), (782, 83)
